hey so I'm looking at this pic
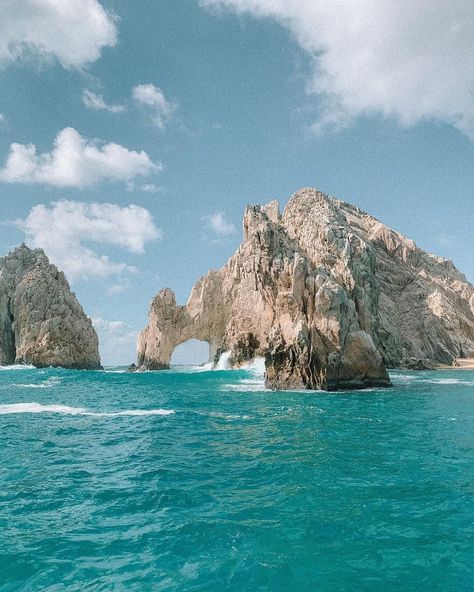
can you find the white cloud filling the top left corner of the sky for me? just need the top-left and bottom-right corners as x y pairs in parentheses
(0, 0), (117, 68)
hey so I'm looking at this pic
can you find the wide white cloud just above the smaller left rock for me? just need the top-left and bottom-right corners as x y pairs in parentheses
(17, 200), (161, 281)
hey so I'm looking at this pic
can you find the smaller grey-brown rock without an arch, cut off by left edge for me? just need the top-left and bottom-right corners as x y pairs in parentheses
(0, 245), (101, 369)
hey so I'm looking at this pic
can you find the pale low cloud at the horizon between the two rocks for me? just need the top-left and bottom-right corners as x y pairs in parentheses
(92, 317), (138, 365)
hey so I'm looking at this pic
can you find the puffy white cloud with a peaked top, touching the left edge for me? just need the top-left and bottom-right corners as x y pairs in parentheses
(0, 127), (161, 187)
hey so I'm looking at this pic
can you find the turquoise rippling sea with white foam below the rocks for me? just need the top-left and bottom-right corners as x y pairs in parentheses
(0, 364), (474, 592)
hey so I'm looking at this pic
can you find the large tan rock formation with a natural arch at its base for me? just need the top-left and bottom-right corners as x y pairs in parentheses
(138, 189), (474, 390)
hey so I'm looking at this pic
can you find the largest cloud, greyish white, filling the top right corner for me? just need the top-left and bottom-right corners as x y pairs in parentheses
(205, 0), (474, 140)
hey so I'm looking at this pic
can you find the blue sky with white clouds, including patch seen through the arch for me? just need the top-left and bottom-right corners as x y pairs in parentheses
(0, 0), (474, 365)
